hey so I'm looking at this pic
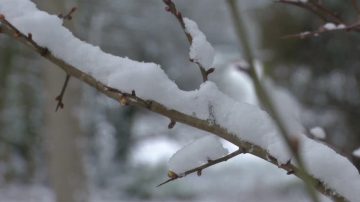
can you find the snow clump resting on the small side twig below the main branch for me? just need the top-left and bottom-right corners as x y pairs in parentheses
(169, 135), (228, 174)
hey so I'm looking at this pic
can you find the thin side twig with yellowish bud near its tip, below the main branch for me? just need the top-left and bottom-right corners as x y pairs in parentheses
(156, 149), (245, 187)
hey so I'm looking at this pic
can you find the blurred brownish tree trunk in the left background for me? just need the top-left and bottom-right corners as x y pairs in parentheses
(36, 0), (88, 202)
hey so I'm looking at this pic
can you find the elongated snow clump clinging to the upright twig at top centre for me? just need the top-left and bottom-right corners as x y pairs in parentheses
(184, 18), (215, 69)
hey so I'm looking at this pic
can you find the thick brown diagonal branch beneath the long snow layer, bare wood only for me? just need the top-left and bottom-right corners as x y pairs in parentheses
(0, 14), (346, 201)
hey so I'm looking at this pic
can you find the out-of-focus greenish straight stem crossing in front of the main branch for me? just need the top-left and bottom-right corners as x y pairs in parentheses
(227, 0), (319, 202)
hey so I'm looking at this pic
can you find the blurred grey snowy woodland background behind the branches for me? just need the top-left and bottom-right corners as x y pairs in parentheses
(0, 0), (360, 202)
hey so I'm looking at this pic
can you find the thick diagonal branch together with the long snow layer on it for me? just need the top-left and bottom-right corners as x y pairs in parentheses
(0, 0), (360, 201)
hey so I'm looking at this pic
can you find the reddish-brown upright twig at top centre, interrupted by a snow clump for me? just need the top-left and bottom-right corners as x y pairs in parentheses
(163, 0), (210, 82)
